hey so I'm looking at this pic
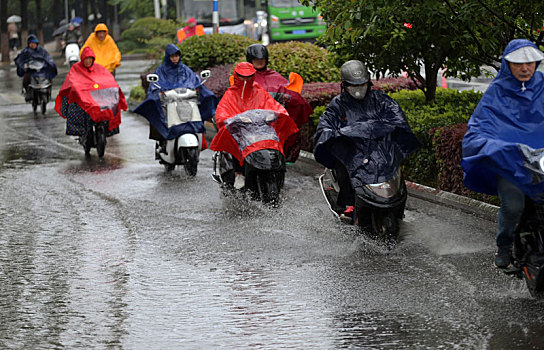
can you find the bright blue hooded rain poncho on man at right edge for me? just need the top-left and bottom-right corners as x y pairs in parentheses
(461, 39), (544, 197)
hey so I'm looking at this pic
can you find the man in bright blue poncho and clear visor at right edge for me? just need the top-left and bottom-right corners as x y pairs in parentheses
(461, 39), (544, 268)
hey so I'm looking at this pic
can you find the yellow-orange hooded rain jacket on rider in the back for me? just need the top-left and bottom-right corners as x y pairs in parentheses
(79, 23), (121, 72)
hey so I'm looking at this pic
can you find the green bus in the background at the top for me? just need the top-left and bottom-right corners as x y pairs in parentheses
(266, 0), (326, 42)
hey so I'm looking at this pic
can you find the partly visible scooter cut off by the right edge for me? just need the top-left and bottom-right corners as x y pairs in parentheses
(504, 150), (544, 299)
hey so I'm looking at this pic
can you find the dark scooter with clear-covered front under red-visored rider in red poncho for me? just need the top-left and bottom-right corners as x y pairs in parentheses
(211, 110), (286, 207)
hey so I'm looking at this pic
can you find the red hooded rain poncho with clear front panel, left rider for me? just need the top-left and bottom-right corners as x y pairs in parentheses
(55, 47), (127, 130)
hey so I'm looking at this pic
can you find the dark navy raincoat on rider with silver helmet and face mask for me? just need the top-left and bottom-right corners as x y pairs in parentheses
(314, 89), (420, 188)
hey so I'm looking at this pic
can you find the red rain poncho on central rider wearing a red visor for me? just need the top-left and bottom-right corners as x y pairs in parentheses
(210, 62), (298, 165)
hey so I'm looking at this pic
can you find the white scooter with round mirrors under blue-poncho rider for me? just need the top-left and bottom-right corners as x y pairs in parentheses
(146, 70), (211, 176)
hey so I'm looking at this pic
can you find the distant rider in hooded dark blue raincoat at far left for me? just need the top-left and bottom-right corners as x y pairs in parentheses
(15, 34), (57, 101)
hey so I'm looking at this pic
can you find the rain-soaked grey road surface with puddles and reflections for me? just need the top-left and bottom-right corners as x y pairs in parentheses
(0, 54), (544, 349)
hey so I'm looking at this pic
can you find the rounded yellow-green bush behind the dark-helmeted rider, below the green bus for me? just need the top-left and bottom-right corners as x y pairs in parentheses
(268, 41), (340, 83)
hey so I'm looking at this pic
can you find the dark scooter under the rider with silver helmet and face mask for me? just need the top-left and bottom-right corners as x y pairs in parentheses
(319, 167), (408, 245)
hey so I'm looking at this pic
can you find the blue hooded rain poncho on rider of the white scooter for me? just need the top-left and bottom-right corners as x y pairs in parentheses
(133, 44), (218, 140)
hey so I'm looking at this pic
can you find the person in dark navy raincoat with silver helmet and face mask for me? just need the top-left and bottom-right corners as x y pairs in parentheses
(314, 60), (420, 222)
